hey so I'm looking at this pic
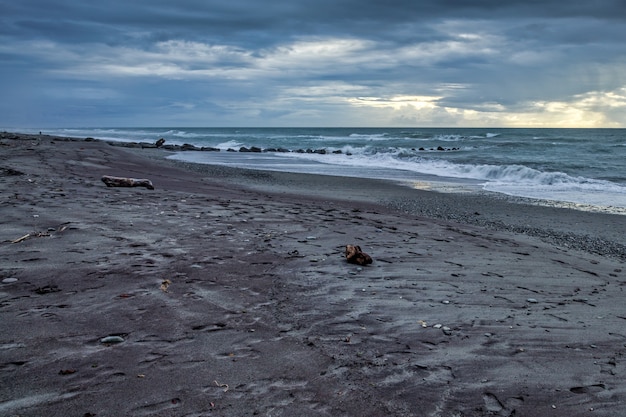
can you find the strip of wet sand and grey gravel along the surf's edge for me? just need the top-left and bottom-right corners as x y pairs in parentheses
(2, 132), (626, 261)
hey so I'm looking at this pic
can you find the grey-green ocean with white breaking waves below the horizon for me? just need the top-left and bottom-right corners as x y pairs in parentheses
(25, 128), (626, 214)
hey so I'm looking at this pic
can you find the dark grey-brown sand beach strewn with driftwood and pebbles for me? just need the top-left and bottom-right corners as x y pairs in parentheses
(0, 133), (626, 417)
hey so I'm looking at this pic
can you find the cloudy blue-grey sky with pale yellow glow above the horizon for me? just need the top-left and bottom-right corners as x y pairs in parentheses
(0, 0), (626, 129)
